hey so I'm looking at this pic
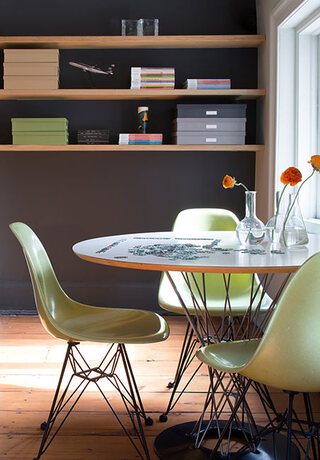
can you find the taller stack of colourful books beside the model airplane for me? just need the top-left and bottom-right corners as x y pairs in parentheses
(131, 67), (175, 89)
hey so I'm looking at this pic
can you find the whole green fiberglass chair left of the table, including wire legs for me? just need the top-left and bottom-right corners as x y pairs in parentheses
(10, 222), (169, 460)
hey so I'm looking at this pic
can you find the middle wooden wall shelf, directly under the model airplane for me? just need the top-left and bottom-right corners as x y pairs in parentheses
(0, 89), (266, 100)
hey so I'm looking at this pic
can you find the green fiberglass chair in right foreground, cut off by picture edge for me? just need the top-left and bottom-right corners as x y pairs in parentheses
(197, 253), (320, 459)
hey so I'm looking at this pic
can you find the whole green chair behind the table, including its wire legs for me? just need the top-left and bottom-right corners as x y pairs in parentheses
(158, 208), (272, 422)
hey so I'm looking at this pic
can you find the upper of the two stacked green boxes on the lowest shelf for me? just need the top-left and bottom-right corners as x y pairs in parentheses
(11, 118), (68, 132)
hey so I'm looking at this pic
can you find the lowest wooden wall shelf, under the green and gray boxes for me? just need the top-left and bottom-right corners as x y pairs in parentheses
(0, 144), (264, 152)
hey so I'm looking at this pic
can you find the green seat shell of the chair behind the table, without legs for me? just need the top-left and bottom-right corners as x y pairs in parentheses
(158, 208), (271, 317)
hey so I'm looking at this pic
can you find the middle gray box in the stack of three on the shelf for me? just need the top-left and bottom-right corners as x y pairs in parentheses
(174, 118), (246, 132)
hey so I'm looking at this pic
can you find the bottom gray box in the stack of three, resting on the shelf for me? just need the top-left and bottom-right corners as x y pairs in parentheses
(173, 131), (245, 145)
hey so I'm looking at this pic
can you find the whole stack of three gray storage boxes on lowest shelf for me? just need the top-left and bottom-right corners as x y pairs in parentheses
(173, 104), (247, 145)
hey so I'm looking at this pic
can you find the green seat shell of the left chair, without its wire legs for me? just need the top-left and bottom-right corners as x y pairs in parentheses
(10, 222), (169, 344)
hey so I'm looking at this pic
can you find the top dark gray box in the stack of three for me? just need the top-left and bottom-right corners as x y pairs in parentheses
(177, 104), (247, 118)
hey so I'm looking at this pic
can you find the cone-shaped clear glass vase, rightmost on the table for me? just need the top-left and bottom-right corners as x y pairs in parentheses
(282, 193), (309, 247)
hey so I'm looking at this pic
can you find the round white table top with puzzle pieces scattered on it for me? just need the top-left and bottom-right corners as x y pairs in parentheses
(73, 232), (320, 273)
